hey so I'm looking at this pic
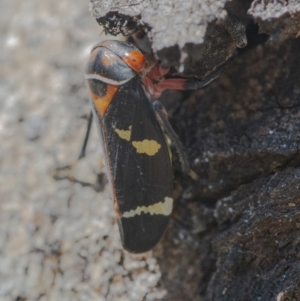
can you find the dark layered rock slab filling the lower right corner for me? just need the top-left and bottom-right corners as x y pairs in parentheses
(208, 168), (300, 301)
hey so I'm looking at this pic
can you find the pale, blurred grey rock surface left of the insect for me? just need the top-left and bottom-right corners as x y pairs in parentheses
(0, 0), (164, 301)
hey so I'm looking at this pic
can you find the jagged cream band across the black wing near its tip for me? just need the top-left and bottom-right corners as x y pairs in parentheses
(122, 197), (173, 217)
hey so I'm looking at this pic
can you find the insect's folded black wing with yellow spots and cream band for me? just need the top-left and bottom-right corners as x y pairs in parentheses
(94, 77), (173, 253)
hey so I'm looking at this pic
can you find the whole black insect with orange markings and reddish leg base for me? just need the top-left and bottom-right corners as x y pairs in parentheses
(85, 40), (227, 253)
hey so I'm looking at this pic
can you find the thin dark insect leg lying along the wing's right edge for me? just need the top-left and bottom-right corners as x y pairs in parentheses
(152, 100), (190, 173)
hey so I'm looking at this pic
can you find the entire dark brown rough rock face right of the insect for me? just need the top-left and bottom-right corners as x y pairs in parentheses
(155, 39), (300, 301)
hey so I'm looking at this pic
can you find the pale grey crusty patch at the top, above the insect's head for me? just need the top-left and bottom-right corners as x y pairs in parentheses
(91, 0), (227, 51)
